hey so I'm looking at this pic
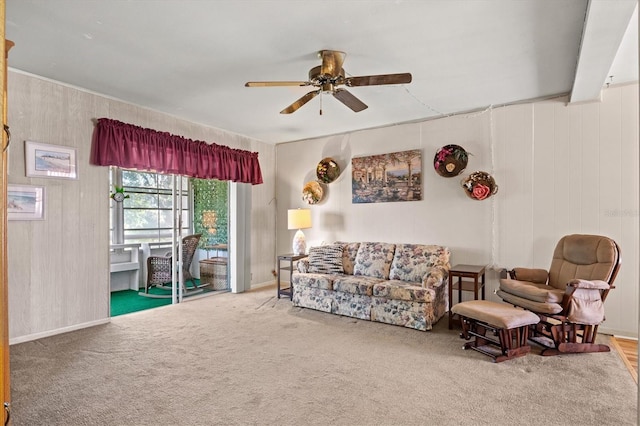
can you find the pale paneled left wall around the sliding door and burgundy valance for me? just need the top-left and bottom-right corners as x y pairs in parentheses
(8, 71), (275, 343)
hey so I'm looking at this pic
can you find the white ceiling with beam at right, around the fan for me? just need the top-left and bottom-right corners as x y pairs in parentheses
(6, 0), (638, 143)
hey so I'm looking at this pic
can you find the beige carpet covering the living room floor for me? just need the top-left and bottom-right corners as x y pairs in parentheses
(11, 288), (637, 426)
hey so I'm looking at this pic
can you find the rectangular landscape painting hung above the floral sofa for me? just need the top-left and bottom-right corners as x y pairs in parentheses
(351, 149), (422, 204)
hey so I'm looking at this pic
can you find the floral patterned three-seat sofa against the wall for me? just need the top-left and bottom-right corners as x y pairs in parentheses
(291, 242), (450, 330)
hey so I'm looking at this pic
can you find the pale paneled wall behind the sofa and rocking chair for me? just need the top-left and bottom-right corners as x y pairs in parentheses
(276, 84), (640, 337)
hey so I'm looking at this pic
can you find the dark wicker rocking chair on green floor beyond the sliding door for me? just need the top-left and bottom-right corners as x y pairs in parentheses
(144, 234), (202, 293)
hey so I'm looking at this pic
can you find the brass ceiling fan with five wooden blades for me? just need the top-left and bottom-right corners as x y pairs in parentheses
(245, 50), (411, 114)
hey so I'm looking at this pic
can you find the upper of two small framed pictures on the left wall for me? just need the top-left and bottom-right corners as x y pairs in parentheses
(25, 141), (78, 179)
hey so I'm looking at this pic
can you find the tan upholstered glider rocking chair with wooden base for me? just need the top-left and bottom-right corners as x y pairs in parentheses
(496, 234), (620, 355)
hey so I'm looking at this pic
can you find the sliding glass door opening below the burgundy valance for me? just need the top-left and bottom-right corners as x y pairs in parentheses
(110, 167), (230, 314)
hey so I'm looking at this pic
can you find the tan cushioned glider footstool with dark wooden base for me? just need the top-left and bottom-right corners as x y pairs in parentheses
(451, 300), (540, 362)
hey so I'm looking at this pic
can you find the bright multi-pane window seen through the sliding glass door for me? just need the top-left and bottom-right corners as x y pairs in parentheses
(111, 167), (192, 244)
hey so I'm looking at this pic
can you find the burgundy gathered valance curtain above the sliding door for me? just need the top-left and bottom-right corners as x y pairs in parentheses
(91, 118), (262, 185)
